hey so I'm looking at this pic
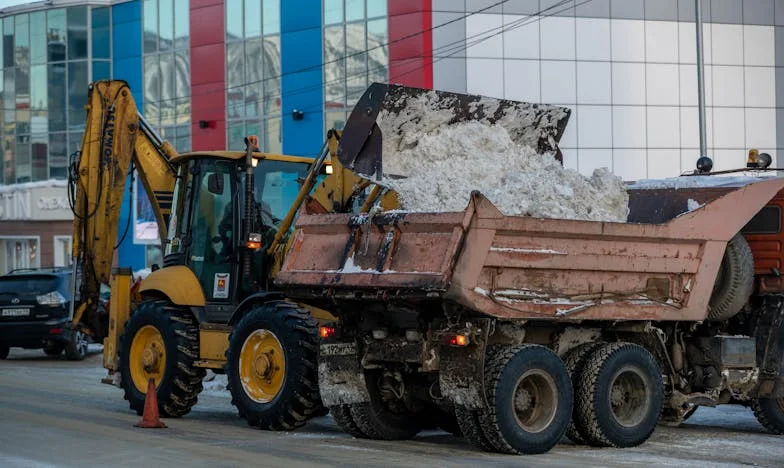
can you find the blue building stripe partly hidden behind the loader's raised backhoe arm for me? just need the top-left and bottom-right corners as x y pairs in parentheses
(112, 0), (146, 270)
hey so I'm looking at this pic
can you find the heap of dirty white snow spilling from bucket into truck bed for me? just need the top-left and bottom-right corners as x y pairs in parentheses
(384, 119), (629, 222)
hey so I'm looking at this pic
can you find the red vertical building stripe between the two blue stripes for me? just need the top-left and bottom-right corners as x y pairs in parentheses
(190, 0), (226, 151)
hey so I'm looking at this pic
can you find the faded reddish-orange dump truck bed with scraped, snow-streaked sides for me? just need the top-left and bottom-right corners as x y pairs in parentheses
(276, 178), (784, 321)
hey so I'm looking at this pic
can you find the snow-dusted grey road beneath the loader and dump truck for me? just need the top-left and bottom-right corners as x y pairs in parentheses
(0, 349), (784, 468)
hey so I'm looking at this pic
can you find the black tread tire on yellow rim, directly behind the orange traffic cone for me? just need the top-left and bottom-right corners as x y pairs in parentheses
(118, 300), (205, 418)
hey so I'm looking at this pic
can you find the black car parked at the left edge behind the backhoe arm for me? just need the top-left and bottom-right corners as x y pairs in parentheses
(0, 268), (87, 360)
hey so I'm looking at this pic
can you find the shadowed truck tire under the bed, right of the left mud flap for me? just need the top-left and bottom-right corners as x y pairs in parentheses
(349, 374), (422, 440)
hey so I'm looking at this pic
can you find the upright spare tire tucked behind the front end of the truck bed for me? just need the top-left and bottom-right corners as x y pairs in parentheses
(708, 234), (754, 321)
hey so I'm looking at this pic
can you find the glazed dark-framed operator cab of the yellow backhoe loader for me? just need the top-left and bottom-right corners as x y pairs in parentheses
(164, 152), (312, 323)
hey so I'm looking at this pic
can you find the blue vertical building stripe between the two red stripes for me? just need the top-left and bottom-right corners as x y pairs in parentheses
(280, 0), (325, 156)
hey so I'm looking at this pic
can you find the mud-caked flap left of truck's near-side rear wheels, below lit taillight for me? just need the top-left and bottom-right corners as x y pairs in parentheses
(438, 321), (489, 409)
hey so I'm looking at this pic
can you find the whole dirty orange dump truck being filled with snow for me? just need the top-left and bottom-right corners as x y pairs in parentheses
(276, 86), (784, 454)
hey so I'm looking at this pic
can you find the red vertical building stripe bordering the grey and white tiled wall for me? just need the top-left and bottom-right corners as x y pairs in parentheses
(387, 0), (433, 88)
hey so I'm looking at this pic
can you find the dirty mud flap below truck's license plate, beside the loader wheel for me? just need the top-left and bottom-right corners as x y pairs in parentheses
(319, 342), (370, 406)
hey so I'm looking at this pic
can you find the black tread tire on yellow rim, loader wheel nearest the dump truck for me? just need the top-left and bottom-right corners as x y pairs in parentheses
(226, 301), (324, 431)
